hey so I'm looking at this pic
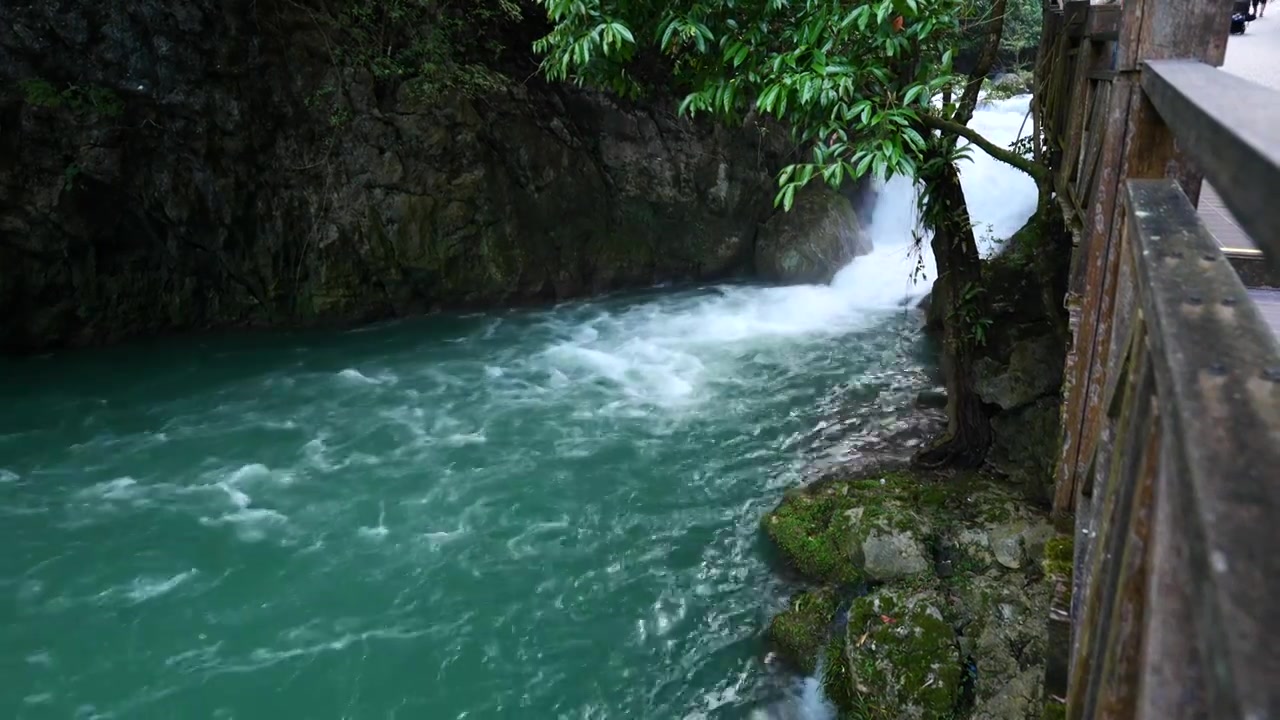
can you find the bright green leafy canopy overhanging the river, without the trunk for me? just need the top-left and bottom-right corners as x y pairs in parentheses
(534, 0), (975, 209)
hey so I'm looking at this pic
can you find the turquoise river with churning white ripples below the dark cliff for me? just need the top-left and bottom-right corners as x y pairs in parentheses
(0, 96), (1027, 720)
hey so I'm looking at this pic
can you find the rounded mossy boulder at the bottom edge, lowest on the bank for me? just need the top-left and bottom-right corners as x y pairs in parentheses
(823, 587), (961, 720)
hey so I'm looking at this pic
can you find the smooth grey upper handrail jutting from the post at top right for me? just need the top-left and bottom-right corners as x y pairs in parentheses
(1142, 60), (1280, 269)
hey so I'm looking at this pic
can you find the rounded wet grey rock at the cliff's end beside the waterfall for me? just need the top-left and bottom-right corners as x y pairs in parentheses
(755, 182), (872, 283)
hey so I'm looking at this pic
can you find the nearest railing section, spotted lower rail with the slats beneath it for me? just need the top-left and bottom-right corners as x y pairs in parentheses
(1068, 179), (1280, 720)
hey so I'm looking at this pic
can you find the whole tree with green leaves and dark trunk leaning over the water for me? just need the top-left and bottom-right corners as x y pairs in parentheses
(535, 0), (1050, 466)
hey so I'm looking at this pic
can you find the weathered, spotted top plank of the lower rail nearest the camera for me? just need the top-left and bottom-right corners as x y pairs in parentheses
(1125, 179), (1280, 717)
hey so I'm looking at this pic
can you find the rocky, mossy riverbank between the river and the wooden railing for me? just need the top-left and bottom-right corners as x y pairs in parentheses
(762, 204), (1064, 720)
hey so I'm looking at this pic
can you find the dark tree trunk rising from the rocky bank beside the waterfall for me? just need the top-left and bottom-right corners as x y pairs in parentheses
(915, 163), (992, 468)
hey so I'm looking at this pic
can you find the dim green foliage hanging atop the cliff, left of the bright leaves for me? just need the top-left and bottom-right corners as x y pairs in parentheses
(332, 0), (521, 100)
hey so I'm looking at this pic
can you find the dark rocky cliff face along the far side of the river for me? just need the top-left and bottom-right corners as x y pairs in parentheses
(0, 0), (856, 350)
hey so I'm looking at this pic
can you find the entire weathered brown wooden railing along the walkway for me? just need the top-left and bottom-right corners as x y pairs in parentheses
(1037, 0), (1280, 720)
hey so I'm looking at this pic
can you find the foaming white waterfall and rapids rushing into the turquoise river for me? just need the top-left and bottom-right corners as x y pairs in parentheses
(529, 97), (1036, 414)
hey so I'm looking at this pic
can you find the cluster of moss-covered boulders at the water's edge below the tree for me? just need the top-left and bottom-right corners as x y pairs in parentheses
(764, 470), (1070, 720)
